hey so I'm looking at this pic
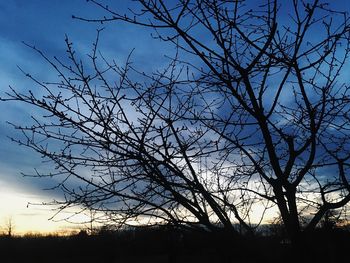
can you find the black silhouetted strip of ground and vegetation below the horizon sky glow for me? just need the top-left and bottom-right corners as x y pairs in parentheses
(0, 227), (350, 263)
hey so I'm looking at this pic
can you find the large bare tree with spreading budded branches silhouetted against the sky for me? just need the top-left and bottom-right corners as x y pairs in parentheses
(5, 0), (350, 248)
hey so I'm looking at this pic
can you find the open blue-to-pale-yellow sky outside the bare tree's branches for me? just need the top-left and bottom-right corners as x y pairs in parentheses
(0, 0), (350, 233)
